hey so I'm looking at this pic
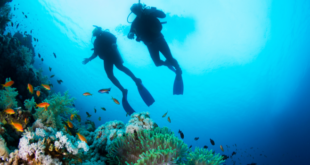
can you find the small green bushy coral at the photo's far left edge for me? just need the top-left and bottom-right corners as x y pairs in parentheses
(0, 87), (18, 109)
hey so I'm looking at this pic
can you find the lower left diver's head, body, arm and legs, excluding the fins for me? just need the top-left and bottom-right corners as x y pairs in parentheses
(83, 26), (141, 97)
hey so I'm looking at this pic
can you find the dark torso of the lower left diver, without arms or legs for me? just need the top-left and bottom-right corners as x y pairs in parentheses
(94, 31), (124, 64)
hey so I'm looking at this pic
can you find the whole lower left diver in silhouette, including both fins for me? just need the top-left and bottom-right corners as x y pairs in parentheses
(83, 25), (155, 115)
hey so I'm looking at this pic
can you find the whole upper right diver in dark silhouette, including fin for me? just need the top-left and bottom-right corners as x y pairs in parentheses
(127, 2), (183, 95)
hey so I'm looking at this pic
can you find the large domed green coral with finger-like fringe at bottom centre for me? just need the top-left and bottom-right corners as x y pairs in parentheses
(107, 128), (188, 164)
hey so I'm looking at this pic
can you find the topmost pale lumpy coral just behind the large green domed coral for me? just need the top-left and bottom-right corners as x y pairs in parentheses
(126, 112), (157, 133)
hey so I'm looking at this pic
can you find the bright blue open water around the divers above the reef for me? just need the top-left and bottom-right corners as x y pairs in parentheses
(7, 0), (310, 165)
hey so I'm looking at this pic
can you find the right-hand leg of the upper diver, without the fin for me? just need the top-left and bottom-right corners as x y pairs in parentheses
(156, 37), (182, 74)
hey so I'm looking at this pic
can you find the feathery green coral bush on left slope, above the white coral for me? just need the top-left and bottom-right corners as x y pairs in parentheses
(34, 92), (77, 130)
